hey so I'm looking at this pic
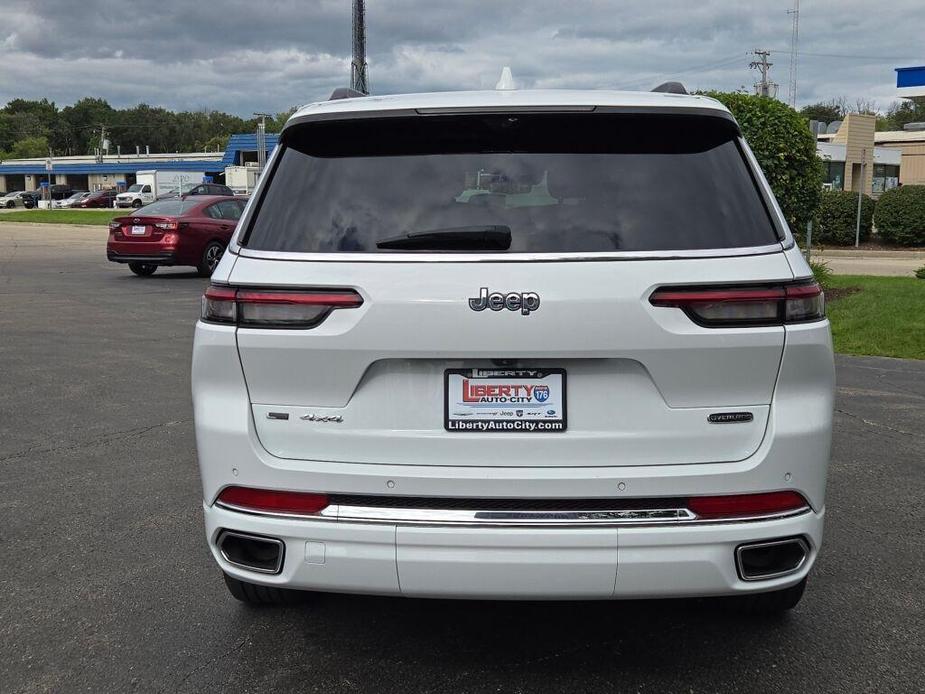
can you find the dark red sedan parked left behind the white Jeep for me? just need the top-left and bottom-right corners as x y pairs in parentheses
(106, 195), (244, 277)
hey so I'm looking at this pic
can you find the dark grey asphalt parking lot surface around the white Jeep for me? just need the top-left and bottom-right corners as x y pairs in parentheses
(0, 223), (925, 693)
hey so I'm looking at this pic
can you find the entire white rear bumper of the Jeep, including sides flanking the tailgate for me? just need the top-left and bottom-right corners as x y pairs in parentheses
(192, 324), (834, 599)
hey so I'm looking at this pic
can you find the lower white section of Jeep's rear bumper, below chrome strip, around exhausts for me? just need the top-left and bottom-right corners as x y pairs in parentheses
(204, 505), (824, 600)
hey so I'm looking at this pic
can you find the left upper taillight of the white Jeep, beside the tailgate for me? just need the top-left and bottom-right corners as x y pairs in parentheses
(201, 287), (363, 329)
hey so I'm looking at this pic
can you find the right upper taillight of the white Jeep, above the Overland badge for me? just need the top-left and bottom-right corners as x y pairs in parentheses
(649, 282), (825, 328)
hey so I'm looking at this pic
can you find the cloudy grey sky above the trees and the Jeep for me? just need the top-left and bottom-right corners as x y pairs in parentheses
(0, 0), (925, 115)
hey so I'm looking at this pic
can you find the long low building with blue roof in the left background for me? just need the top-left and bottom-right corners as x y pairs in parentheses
(0, 133), (277, 192)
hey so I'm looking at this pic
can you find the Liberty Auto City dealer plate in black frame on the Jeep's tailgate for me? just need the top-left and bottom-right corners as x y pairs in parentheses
(443, 367), (568, 434)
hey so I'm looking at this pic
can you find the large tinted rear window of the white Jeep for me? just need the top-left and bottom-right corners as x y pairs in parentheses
(243, 113), (779, 253)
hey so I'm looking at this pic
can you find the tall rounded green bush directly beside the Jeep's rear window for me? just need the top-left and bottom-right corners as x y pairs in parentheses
(706, 92), (822, 234)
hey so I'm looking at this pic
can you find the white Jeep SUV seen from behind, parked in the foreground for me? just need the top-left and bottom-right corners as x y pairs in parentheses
(192, 91), (834, 610)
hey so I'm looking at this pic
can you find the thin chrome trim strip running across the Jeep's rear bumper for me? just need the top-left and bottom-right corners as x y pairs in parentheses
(215, 502), (810, 528)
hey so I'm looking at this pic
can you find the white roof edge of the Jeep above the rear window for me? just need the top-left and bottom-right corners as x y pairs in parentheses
(289, 89), (729, 129)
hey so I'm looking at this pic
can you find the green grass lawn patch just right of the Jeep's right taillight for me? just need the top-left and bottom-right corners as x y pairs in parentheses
(826, 275), (925, 359)
